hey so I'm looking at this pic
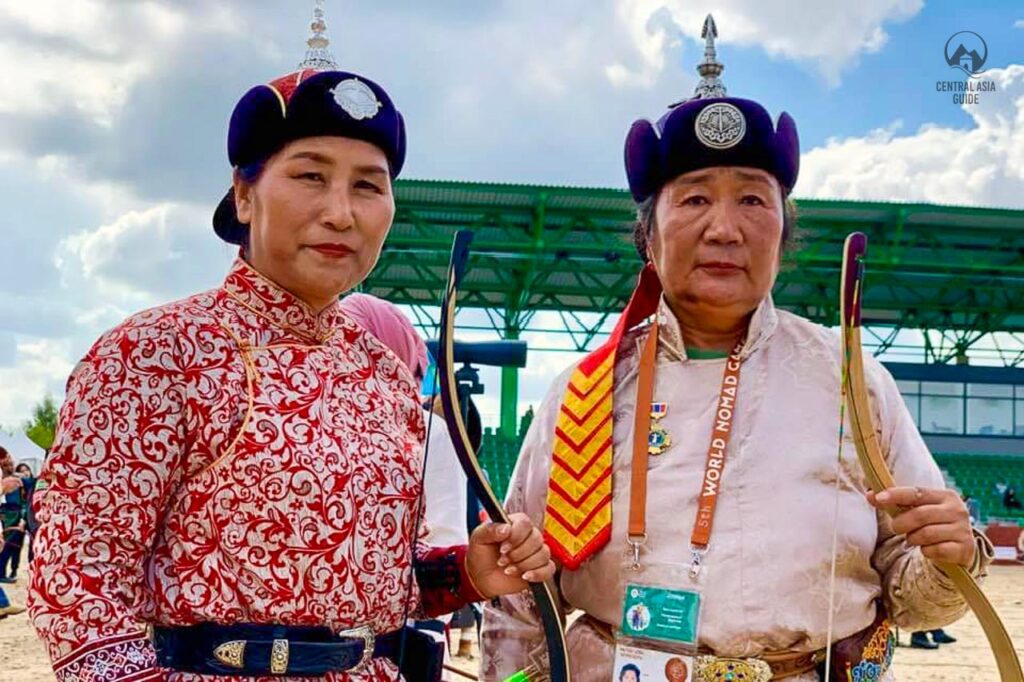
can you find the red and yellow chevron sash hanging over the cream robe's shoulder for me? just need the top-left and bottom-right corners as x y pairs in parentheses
(544, 264), (662, 569)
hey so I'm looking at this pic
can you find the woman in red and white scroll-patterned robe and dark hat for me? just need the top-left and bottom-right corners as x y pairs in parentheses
(29, 66), (554, 682)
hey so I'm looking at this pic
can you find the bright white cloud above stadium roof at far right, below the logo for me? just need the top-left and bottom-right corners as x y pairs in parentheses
(796, 65), (1024, 208)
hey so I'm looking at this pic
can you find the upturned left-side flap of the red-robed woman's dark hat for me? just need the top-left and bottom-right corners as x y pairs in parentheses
(227, 85), (288, 167)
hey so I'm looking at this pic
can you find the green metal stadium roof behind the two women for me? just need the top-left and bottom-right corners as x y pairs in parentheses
(364, 180), (1024, 360)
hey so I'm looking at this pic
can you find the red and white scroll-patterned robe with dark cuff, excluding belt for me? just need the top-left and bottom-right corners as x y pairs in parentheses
(29, 259), (479, 682)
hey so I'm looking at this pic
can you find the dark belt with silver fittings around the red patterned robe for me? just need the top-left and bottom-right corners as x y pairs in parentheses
(153, 623), (401, 677)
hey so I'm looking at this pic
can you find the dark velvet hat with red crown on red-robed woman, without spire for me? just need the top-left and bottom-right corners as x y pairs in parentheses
(213, 69), (406, 244)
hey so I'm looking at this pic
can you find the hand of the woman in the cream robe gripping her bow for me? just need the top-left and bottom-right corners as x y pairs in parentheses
(867, 487), (977, 568)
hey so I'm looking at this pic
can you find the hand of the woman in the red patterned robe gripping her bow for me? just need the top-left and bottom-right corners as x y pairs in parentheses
(466, 514), (555, 599)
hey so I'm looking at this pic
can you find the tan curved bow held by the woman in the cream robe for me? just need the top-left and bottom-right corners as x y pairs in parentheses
(840, 232), (1024, 682)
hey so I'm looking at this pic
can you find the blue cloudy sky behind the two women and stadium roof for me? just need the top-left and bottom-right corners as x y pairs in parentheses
(0, 0), (1024, 450)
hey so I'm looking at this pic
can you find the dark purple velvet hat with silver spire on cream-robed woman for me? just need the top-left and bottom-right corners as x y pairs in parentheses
(626, 14), (800, 203)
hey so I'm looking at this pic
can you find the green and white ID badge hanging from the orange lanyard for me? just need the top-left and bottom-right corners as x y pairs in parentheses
(612, 583), (701, 682)
